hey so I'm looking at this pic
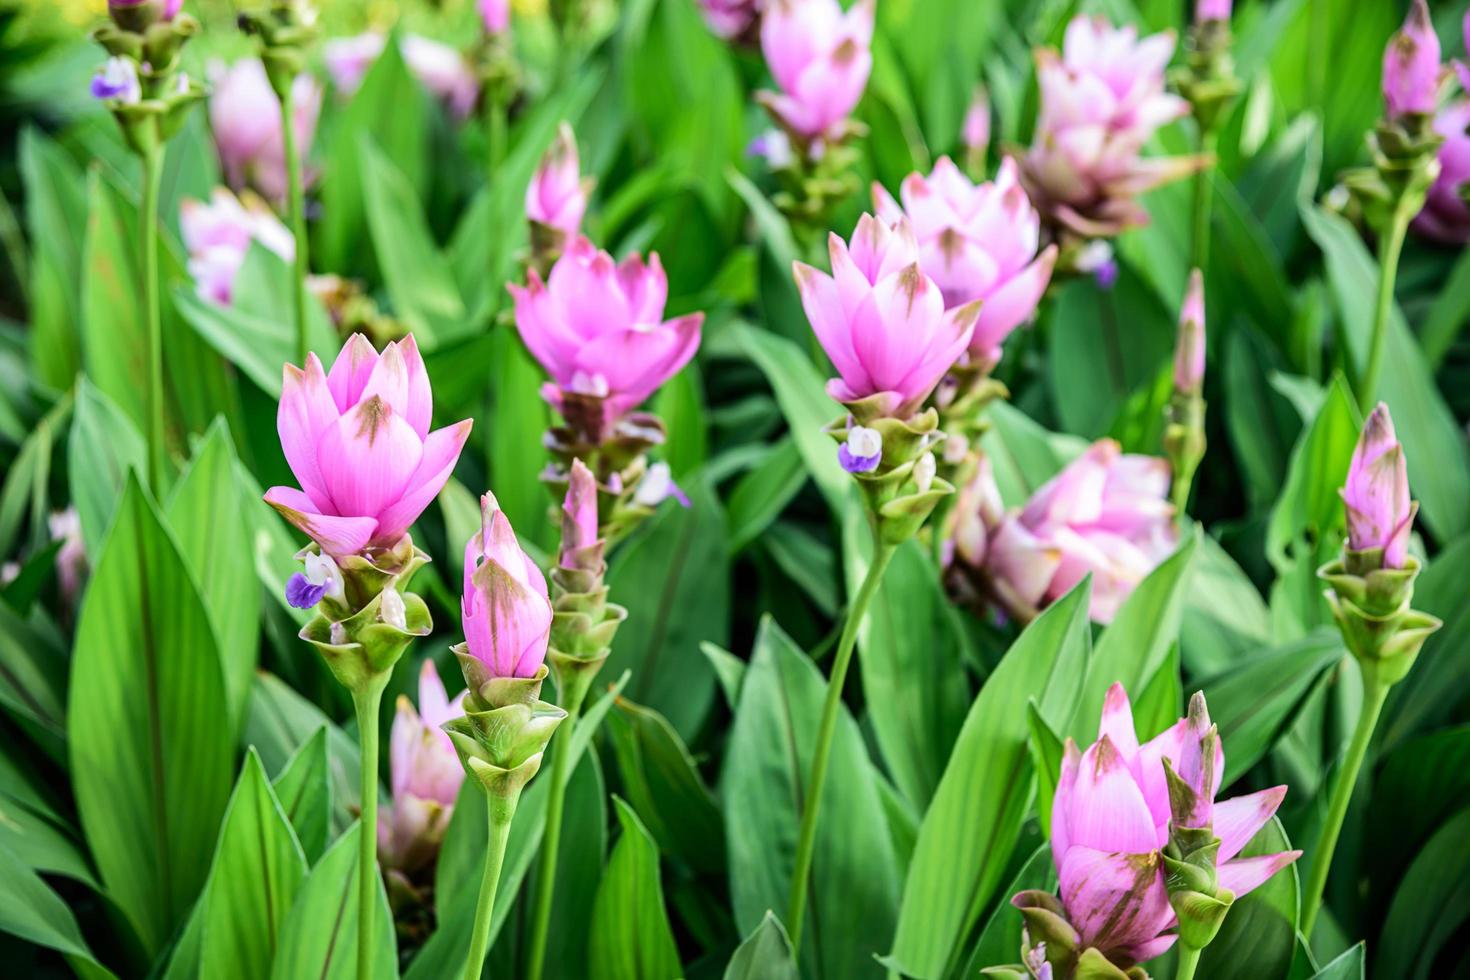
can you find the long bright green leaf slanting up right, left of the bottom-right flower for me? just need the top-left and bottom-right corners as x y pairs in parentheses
(886, 580), (1093, 977)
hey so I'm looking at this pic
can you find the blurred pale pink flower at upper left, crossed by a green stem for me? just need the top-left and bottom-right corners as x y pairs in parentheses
(209, 57), (322, 201)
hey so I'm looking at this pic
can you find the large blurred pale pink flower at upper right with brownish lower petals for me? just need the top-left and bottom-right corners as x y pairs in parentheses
(1022, 16), (1200, 237)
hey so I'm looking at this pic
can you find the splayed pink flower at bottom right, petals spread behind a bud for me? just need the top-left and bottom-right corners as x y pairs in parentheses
(1040, 683), (1301, 965)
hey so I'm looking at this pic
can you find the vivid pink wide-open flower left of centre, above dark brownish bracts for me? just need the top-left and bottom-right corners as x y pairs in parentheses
(509, 237), (704, 419)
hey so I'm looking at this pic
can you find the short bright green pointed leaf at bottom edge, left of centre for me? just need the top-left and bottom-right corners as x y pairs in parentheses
(587, 796), (684, 980)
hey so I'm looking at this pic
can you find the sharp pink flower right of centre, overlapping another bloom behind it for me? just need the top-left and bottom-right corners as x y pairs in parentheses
(794, 215), (978, 419)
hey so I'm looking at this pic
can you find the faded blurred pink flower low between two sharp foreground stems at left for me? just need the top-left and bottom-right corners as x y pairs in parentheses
(378, 661), (465, 874)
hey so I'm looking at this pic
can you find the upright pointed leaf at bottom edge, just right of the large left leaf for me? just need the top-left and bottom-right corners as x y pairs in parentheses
(200, 749), (306, 980)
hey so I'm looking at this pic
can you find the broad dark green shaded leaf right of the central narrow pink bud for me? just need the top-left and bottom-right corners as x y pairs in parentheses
(604, 479), (731, 739)
